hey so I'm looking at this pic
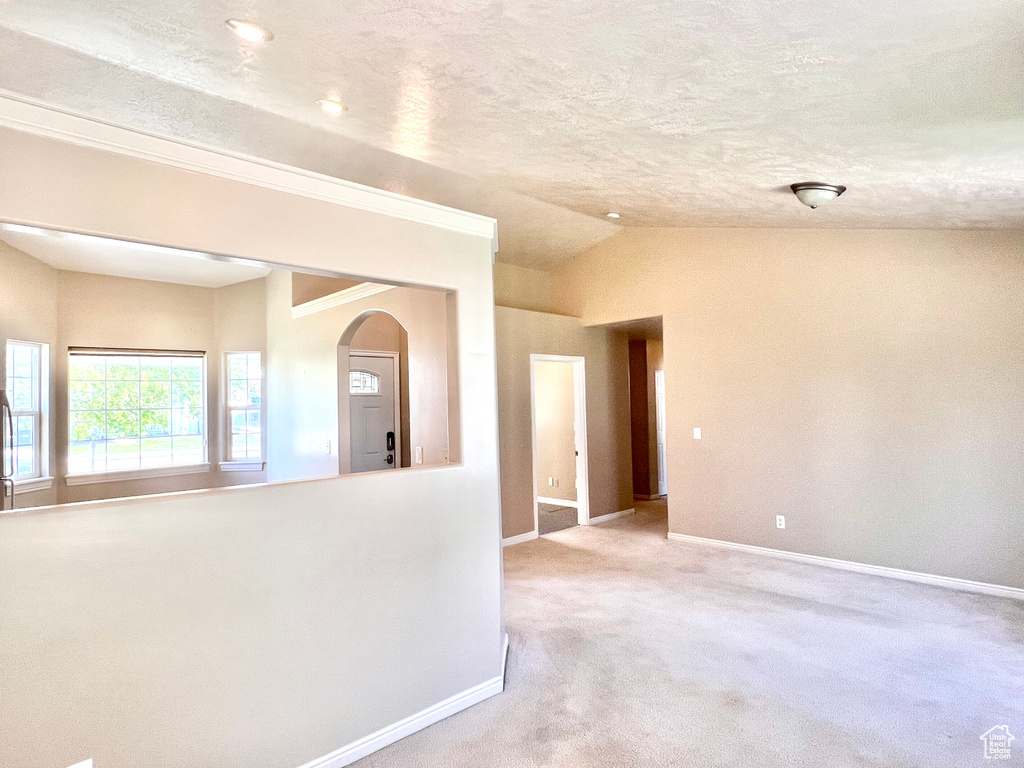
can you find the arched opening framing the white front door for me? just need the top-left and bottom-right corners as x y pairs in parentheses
(338, 309), (412, 474)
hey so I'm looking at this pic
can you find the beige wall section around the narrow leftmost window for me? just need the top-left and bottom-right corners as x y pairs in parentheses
(0, 242), (58, 509)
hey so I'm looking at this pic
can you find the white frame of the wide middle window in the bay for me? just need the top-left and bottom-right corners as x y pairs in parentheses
(65, 347), (210, 485)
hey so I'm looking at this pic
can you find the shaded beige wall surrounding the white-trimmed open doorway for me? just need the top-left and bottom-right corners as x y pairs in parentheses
(496, 307), (633, 538)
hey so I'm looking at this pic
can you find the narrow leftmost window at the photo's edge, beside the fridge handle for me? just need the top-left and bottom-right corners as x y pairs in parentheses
(4, 341), (49, 480)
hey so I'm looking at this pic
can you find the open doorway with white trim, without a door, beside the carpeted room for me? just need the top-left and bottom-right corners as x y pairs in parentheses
(529, 354), (590, 536)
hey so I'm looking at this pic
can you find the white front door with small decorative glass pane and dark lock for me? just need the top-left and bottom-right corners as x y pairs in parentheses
(348, 354), (400, 472)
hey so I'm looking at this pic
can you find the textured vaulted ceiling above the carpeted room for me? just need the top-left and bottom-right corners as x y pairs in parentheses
(0, 0), (1024, 265)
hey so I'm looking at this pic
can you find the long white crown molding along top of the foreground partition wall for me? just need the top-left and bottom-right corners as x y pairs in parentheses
(0, 90), (498, 253)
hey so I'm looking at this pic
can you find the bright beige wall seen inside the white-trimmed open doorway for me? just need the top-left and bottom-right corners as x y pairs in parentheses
(534, 360), (577, 502)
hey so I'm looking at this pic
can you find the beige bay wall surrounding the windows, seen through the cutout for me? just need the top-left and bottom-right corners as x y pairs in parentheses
(0, 243), (266, 508)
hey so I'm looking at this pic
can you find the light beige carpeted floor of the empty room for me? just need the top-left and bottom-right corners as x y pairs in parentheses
(357, 502), (1024, 768)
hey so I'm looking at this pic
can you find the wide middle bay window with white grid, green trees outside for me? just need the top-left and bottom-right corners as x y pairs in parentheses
(68, 350), (206, 475)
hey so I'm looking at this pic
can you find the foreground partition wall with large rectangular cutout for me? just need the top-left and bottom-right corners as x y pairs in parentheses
(0, 124), (503, 768)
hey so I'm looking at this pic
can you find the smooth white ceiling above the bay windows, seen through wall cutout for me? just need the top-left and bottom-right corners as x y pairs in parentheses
(0, 229), (270, 288)
